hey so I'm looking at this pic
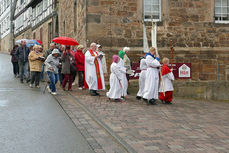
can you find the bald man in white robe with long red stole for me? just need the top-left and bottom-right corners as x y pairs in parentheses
(85, 43), (105, 96)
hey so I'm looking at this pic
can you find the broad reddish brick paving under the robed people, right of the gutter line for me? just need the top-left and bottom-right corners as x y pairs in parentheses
(56, 86), (229, 153)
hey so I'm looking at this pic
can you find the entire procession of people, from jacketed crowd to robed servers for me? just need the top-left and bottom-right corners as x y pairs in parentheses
(11, 41), (174, 105)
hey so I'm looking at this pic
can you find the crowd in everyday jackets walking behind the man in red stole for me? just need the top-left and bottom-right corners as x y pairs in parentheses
(11, 41), (89, 95)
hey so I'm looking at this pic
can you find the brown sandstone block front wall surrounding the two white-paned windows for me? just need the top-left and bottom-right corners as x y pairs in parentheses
(83, 0), (229, 81)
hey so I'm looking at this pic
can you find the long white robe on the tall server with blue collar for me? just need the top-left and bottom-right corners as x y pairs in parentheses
(143, 55), (160, 100)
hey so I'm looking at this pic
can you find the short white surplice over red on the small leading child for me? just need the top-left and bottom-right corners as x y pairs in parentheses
(159, 72), (174, 92)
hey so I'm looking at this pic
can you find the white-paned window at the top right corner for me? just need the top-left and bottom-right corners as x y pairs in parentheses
(215, 0), (229, 23)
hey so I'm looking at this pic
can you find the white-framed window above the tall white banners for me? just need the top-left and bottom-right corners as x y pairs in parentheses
(144, 0), (161, 22)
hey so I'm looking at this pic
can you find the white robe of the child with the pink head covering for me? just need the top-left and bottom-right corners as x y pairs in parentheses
(107, 62), (124, 99)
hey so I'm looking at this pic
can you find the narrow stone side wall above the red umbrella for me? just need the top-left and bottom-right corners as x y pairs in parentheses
(59, 0), (87, 46)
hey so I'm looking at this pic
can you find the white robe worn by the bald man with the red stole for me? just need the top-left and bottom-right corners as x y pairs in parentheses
(85, 51), (105, 90)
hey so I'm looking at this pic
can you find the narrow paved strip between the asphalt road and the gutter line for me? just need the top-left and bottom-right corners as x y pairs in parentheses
(54, 93), (127, 153)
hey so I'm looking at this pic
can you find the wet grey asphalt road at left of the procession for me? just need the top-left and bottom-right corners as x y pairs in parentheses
(0, 54), (93, 153)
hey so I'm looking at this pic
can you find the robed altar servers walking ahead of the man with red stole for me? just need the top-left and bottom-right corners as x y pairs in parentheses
(107, 47), (174, 105)
